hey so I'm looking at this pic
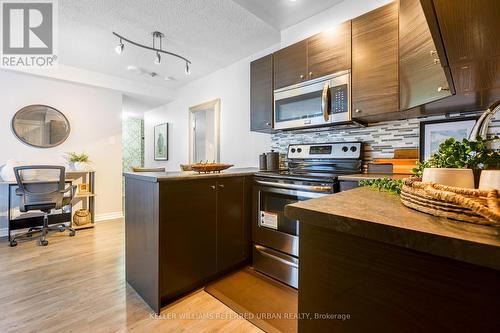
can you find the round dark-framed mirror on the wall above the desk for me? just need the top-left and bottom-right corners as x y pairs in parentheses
(12, 105), (70, 148)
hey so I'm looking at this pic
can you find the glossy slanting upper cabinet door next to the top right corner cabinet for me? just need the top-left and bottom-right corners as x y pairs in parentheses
(399, 0), (451, 110)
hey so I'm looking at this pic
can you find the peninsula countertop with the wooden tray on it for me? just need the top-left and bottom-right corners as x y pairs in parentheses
(123, 168), (259, 183)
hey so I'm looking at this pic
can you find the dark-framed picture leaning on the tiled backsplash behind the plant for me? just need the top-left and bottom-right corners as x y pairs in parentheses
(420, 117), (479, 161)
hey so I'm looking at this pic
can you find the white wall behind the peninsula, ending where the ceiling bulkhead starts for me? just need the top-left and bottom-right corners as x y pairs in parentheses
(144, 45), (278, 170)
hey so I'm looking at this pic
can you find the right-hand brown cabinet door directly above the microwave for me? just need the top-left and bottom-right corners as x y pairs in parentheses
(307, 21), (351, 79)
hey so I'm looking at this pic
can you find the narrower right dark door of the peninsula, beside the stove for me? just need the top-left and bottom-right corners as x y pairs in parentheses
(217, 177), (250, 272)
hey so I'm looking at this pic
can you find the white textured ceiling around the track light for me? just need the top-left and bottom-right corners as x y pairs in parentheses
(58, 0), (342, 88)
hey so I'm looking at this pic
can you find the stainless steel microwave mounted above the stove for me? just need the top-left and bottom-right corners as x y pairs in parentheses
(274, 70), (352, 130)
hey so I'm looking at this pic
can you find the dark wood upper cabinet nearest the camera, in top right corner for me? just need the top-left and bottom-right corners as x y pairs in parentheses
(433, 0), (500, 105)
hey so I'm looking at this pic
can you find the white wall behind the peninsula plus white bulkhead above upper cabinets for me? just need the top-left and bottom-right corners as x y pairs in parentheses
(144, 0), (391, 170)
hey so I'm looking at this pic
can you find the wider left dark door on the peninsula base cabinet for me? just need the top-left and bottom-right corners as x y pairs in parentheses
(159, 179), (217, 298)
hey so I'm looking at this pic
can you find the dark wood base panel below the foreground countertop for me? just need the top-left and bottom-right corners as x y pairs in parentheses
(299, 223), (500, 333)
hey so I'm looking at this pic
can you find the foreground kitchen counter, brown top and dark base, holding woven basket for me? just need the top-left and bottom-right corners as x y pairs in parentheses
(285, 188), (500, 332)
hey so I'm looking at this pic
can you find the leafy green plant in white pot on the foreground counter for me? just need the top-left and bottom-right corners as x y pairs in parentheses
(413, 137), (500, 188)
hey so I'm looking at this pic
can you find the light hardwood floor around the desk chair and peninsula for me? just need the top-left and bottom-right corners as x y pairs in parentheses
(0, 220), (262, 333)
